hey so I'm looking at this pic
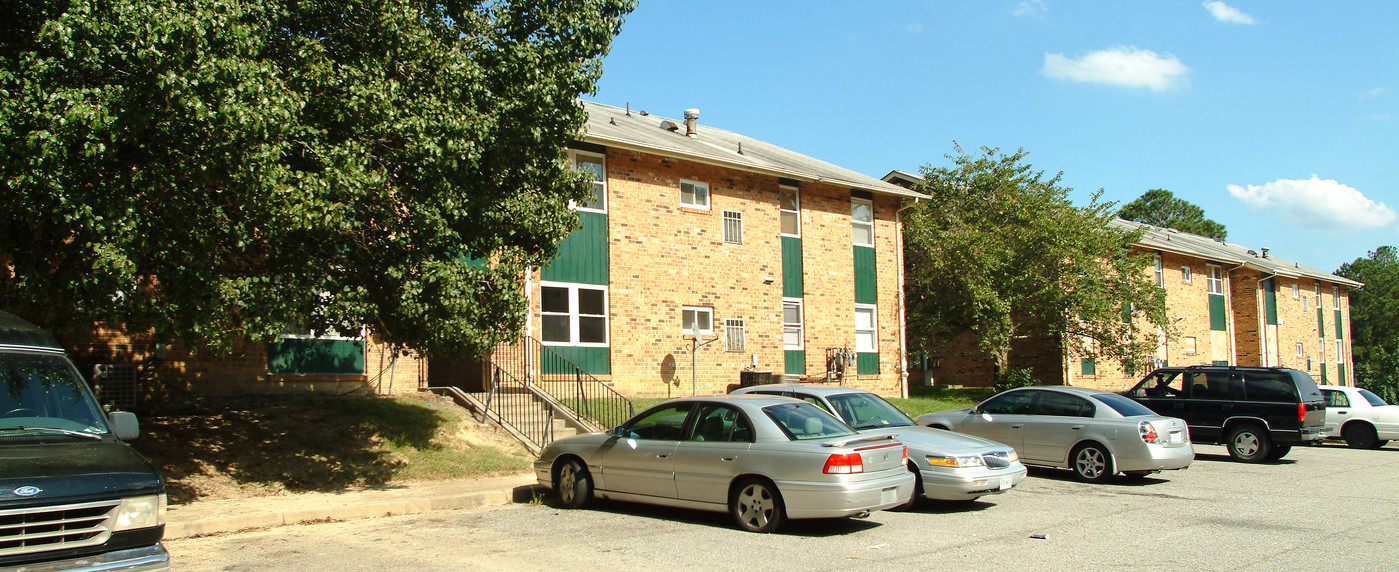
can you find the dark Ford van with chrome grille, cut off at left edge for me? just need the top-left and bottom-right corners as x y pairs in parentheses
(0, 312), (169, 572)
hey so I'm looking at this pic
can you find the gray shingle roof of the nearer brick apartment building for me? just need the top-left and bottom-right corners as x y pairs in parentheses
(581, 101), (928, 199)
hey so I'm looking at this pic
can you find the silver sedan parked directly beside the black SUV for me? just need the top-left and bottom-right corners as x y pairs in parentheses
(918, 386), (1195, 482)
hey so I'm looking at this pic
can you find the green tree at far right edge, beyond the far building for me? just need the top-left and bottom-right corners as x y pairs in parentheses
(1336, 246), (1399, 403)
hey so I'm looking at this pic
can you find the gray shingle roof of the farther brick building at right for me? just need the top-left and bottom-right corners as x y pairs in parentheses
(1111, 218), (1364, 288)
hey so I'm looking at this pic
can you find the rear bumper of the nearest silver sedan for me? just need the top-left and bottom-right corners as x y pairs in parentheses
(775, 470), (914, 519)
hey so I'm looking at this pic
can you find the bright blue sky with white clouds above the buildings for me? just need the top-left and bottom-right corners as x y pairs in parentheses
(588, 0), (1399, 271)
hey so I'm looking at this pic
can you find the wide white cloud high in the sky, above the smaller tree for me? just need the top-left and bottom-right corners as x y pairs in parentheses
(1039, 46), (1191, 91)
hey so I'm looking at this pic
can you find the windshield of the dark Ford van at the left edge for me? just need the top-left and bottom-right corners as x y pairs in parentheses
(0, 354), (108, 435)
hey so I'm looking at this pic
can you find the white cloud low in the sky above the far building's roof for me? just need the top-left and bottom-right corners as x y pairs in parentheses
(1228, 175), (1399, 229)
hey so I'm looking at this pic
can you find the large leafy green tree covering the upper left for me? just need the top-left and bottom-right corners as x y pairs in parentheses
(0, 0), (632, 354)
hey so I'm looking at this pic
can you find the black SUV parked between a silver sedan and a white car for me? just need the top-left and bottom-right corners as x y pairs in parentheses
(1122, 365), (1326, 463)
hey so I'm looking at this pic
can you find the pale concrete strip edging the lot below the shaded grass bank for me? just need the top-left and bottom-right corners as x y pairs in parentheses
(165, 473), (546, 538)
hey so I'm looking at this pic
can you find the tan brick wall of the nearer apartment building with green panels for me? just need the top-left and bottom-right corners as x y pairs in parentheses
(532, 148), (901, 396)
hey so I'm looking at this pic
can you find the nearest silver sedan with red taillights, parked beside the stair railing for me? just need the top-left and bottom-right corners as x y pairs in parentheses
(534, 396), (914, 533)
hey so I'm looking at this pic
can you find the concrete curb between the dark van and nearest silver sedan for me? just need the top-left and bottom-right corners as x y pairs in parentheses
(165, 484), (547, 540)
